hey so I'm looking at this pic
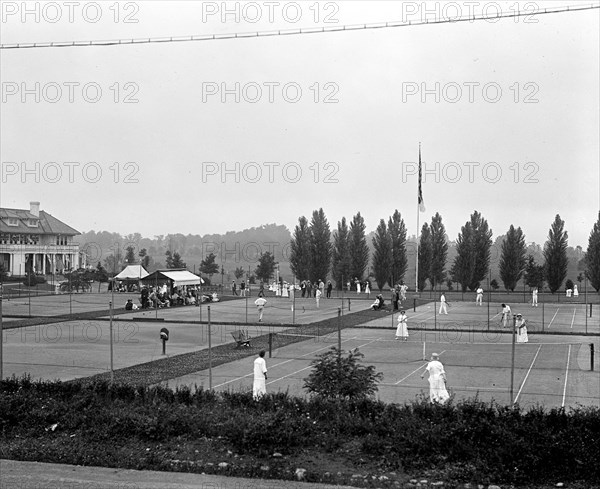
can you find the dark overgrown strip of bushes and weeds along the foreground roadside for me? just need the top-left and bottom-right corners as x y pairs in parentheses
(0, 378), (600, 487)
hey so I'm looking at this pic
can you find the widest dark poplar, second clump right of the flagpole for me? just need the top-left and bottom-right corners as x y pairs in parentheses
(451, 211), (492, 292)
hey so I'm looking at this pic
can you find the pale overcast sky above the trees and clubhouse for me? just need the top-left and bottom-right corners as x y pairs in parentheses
(0, 0), (600, 244)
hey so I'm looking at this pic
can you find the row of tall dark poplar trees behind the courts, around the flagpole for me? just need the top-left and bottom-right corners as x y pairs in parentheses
(290, 208), (600, 293)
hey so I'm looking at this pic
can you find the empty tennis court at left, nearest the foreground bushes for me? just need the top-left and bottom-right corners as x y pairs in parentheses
(3, 320), (282, 381)
